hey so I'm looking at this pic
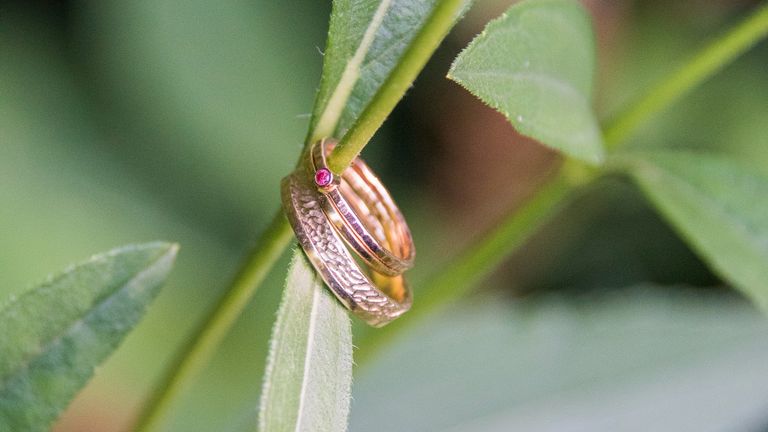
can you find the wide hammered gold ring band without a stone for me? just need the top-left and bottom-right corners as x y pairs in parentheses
(281, 171), (411, 327)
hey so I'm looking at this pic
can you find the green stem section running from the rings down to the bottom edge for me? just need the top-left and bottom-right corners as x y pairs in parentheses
(136, 210), (293, 431)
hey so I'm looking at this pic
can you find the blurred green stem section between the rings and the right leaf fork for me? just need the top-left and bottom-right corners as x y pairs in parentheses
(355, 169), (592, 365)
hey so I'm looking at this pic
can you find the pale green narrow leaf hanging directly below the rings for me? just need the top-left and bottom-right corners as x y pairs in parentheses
(259, 250), (352, 432)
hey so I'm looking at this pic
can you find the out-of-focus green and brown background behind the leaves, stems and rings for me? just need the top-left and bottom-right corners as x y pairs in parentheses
(0, 0), (768, 432)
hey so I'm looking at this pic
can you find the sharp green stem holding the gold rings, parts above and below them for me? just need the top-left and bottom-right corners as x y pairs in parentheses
(136, 0), (466, 432)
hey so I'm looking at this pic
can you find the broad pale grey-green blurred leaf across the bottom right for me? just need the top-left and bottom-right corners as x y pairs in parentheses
(350, 287), (768, 432)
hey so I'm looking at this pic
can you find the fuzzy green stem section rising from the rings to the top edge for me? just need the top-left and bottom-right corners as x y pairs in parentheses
(328, 0), (466, 174)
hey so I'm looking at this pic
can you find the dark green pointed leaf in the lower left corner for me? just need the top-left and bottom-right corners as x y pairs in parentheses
(0, 243), (178, 431)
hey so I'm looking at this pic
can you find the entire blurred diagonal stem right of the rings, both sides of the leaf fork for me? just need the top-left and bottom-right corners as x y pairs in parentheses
(355, 3), (768, 365)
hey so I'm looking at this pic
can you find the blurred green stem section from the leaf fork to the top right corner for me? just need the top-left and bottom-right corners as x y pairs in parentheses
(604, 3), (768, 148)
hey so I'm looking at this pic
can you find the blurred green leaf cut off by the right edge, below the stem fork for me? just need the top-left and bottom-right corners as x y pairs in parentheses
(619, 151), (768, 311)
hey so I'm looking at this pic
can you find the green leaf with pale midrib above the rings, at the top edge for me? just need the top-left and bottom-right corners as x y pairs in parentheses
(310, 0), (466, 139)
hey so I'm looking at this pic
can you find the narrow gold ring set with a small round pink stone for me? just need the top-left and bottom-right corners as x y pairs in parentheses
(308, 141), (415, 276)
